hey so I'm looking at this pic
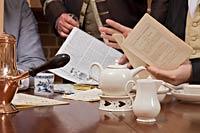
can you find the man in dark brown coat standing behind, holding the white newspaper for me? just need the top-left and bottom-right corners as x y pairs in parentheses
(41, 0), (147, 40)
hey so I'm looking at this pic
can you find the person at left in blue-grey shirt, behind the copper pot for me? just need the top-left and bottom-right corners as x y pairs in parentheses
(4, 0), (46, 90)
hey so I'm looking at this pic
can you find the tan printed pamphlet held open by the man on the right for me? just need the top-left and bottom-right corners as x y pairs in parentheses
(116, 14), (192, 77)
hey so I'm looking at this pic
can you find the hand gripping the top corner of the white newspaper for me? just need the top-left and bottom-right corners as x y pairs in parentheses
(56, 13), (79, 37)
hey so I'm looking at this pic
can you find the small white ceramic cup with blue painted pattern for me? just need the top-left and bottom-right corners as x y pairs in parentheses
(34, 73), (54, 96)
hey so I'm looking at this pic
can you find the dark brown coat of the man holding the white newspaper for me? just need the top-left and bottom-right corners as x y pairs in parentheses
(41, 0), (147, 32)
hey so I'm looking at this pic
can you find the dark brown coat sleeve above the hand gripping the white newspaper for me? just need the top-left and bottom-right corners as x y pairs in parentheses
(40, 0), (66, 34)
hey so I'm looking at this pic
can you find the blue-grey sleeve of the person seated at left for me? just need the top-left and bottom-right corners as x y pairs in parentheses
(17, 0), (46, 87)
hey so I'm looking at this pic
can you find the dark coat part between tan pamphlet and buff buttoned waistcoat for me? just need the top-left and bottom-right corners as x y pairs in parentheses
(151, 0), (188, 40)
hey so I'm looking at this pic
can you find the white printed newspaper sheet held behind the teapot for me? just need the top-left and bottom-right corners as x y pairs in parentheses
(49, 28), (122, 84)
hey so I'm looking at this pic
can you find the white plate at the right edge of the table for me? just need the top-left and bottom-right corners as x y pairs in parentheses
(172, 90), (200, 102)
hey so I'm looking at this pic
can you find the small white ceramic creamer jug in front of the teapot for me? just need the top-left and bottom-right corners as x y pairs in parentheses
(125, 79), (163, 123)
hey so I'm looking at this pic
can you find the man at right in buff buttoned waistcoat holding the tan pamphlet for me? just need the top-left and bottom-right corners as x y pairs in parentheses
(99, 0), (200, 85)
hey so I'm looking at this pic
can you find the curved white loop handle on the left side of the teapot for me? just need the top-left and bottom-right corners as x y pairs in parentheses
(89, 62), (103, 82)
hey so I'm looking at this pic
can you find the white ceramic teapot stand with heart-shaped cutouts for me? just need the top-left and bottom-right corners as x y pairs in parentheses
(99, 95), (135, 111)
